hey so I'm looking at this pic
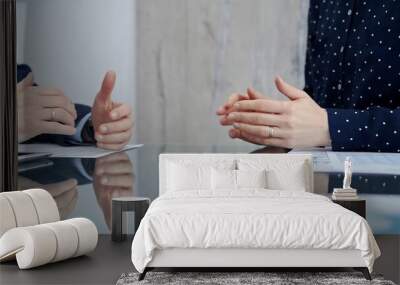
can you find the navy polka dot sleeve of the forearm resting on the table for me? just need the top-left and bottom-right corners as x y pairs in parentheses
(326, 107), (400, 152)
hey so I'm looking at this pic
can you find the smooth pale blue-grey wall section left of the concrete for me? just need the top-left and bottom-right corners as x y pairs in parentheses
(18, 0), (136, 125)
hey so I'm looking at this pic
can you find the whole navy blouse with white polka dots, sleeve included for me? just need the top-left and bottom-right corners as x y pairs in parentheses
(305, 0), (400, 152)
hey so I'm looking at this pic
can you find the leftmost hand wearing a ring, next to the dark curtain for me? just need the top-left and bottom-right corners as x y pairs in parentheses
(17, 73), (77, 142)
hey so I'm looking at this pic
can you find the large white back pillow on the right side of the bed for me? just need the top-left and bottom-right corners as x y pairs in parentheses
(238, 157), (310, 191)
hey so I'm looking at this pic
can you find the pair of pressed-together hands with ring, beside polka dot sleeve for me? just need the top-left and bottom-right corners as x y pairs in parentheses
(217, 77), (331, 148)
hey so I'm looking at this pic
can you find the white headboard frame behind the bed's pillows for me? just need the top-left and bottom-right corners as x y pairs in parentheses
(159, 153), (314, 195)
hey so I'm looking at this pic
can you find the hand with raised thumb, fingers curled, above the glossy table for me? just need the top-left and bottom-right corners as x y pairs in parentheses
(92, 71), (133, 150)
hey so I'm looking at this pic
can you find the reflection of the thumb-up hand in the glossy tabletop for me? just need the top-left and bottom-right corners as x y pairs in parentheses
(93, 152), (134, 228)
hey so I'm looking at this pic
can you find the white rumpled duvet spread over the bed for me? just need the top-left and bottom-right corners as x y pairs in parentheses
(132, 189), (380, 272)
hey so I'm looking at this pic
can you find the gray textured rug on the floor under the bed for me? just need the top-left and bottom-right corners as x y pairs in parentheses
(117, 272), (395, 285)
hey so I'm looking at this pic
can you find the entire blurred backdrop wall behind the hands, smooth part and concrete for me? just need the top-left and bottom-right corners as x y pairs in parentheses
(18, 0), (308, 145)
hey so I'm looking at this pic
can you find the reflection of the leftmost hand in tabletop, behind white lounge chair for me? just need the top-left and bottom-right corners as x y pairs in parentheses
(18, 176), (78, 219)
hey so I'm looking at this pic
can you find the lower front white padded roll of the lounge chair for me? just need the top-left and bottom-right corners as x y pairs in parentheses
(0, 218), (98, 269)
